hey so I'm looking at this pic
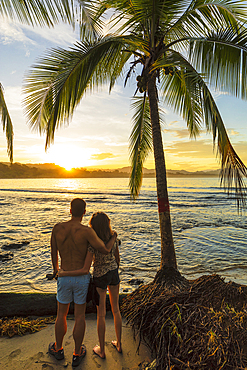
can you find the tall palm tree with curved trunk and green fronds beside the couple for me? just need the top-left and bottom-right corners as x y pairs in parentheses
(24, 0), (247, 269)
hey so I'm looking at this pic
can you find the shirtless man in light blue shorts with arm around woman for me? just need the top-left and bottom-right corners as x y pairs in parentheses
(48, 198), (116, 366)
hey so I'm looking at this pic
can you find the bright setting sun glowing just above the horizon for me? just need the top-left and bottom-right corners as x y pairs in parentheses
(46, 144), (91, 171)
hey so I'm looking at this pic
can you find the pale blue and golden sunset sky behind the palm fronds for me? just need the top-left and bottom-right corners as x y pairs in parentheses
(0, 12), (247, 171)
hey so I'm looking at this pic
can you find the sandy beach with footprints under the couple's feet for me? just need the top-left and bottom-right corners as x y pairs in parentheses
(0, 312), (152, 370)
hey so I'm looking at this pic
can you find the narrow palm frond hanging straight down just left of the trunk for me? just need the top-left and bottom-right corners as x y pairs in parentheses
(129, 93), (152, 199)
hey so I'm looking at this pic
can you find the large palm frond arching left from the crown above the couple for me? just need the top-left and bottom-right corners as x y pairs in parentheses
(24, 35), (141, 148)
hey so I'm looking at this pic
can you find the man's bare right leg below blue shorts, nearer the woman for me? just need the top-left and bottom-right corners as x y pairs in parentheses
(73, 303), (86, 355)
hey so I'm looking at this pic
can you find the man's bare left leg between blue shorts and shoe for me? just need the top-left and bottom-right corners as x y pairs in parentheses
(55, 302), (70, 350)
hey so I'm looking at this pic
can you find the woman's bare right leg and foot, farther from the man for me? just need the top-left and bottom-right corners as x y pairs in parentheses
(108, 284), (122, 353)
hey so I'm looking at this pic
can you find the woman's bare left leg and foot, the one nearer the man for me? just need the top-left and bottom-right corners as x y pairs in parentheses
(93, 288), (107, 358)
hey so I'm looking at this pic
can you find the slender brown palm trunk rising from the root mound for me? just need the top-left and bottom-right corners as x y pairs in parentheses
(148, 75), (177, 269)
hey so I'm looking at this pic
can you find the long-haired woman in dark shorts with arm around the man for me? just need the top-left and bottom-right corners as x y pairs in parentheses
(59, 212), (122, 359)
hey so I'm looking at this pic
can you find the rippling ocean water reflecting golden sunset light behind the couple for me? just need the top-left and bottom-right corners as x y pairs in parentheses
(0, 178), (247, 292)
